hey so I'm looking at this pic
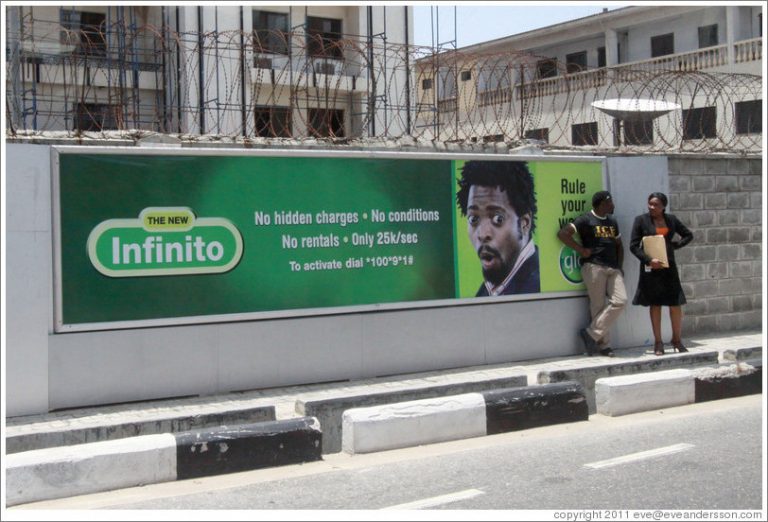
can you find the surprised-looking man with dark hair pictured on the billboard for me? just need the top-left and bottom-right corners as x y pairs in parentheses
(456, 161), (541, 297)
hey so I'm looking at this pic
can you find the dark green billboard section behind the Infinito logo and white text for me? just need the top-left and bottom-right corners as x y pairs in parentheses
(60, 154), (455, 324)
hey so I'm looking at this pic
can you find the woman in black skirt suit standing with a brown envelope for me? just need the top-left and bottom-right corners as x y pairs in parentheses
(629, 192), (693, 355)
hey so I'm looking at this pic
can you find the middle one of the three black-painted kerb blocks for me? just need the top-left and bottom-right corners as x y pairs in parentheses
(483, 382), (589, 435)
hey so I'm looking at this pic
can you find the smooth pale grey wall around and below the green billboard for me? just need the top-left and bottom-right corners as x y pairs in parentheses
(4, 144), (760, 416)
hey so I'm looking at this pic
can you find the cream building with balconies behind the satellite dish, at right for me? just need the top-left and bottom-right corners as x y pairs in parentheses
(416, 5), (764, 150)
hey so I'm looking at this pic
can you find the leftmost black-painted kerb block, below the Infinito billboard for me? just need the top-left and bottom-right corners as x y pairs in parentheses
(175, 417), (322, 480)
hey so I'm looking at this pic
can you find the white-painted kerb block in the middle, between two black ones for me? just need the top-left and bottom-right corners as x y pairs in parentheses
(342, 393), (486, 453)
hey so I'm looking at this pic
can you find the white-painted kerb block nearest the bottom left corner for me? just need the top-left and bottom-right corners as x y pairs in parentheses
(5, 434), (176, 506)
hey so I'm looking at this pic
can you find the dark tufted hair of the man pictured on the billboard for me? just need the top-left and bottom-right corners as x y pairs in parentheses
(456, 161), (536, 234)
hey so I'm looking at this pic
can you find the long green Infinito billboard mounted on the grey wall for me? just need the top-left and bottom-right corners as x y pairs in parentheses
(54, 150), (603, 331)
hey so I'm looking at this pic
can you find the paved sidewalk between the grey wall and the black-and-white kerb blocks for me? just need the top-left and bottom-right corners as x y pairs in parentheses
(5, 331), (763, 453)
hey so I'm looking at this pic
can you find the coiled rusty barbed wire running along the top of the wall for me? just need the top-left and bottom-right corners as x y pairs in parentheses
(6, 24), (762, 153)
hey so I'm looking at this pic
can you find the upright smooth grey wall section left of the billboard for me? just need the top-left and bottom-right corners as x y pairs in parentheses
(3, 141), (53, 416)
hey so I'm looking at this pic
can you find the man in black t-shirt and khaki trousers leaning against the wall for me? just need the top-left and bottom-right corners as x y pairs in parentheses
(557, 190), (627, 357)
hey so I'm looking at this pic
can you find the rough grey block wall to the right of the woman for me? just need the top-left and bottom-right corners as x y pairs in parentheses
(669, 156), (764, 332)
